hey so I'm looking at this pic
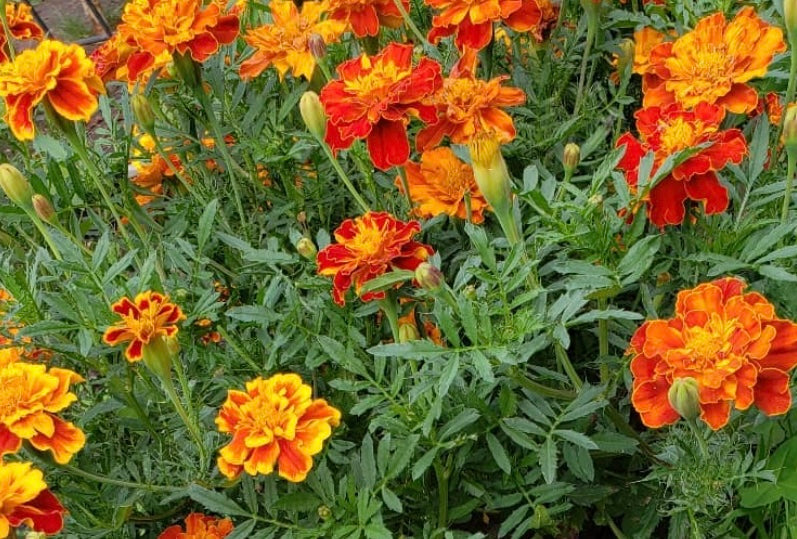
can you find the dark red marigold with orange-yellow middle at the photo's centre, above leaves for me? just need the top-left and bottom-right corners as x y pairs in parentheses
(316, 212), (434, 306)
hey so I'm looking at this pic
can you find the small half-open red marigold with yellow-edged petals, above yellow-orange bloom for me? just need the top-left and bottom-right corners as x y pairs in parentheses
(102, 291), (185, 362)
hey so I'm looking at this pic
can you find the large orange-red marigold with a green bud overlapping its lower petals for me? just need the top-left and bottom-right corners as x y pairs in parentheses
(628, 277), (797, 430)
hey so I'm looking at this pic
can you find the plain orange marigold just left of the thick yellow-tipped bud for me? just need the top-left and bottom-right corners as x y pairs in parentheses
(396, 147), (487, 223)
